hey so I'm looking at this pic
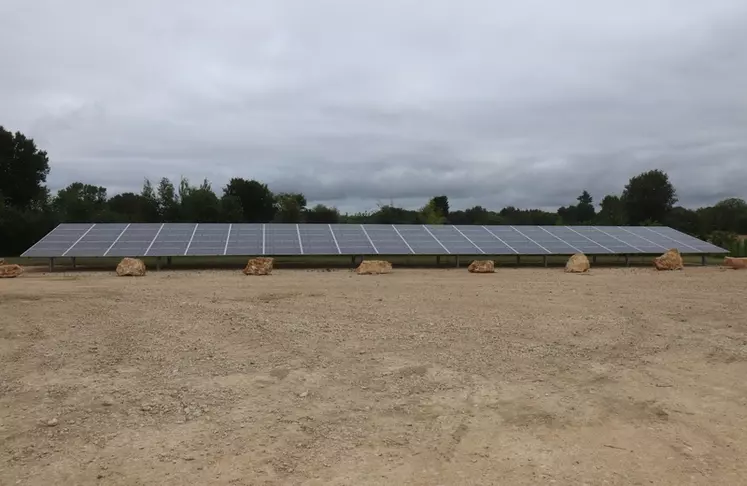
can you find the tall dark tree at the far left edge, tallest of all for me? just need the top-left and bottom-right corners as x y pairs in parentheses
(0, 126), (49, 209)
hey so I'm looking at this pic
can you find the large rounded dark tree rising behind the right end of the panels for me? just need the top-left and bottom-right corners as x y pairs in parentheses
(622, 170), (677, 224)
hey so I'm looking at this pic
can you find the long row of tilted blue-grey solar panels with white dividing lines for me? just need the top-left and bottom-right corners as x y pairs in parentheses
(22, 223), (726, 258)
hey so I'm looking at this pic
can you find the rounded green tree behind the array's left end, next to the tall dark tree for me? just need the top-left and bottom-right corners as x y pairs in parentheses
(52, 182), (109, 223)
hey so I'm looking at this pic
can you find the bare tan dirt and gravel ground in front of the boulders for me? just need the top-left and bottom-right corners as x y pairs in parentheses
(0, 268), (747, 486)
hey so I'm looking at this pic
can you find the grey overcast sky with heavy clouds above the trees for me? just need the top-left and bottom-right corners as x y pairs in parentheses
(0, 0), (747, 210)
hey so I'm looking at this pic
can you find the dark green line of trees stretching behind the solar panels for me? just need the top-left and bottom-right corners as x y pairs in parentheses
(0, 126), (747, 256)
